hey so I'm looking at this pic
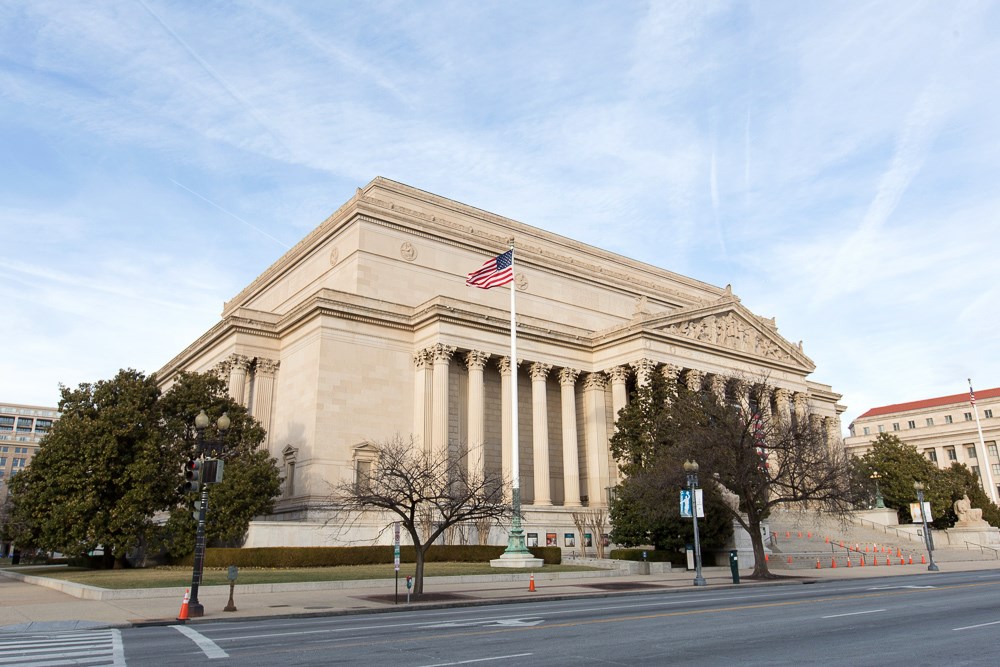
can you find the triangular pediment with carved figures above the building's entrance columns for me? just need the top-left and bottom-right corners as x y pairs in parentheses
(647, 296), (815, 368)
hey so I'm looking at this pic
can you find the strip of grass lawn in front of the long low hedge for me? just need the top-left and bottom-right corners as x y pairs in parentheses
(5, 563), (600, 588)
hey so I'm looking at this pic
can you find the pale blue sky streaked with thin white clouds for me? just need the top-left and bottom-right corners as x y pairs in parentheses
(0, 0), (1000, 427)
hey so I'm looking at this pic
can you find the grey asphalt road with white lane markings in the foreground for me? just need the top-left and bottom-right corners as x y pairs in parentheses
(0, 571), (1000, 667)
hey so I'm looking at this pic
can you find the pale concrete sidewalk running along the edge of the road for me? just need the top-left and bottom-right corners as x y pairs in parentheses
(0, 561), (1000, 632)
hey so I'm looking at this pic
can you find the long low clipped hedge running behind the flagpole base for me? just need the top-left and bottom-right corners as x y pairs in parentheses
(173, 545), (562, 568)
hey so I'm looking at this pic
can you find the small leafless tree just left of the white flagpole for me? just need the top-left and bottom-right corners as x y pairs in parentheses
(333, 435), (512, 595)
